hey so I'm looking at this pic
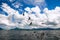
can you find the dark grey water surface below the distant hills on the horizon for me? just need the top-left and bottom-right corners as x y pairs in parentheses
(0, 30), (60, 40)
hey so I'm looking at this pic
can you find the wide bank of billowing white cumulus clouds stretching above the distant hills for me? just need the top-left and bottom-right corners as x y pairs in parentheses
(0, 3), (60, 29)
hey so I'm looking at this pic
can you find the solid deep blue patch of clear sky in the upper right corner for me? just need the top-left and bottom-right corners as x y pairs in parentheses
(46, 0), (60, 9)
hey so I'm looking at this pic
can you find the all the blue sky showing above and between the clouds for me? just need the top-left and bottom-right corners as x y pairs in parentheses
(0, 0), (60, 15)
